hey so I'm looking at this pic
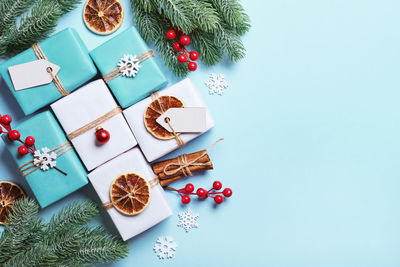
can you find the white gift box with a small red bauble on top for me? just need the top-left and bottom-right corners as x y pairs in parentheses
(51, 80), (137, 171)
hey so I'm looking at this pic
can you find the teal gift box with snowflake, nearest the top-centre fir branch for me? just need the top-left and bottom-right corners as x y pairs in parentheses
(90, 27), (168, 108)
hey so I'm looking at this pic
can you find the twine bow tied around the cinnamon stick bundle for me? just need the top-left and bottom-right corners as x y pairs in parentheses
(163, 138), (224, 177)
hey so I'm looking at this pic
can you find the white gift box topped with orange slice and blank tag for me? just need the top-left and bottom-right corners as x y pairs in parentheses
(124, 78), (214, 162)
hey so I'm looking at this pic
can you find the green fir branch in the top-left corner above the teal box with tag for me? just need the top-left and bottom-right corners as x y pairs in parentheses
(0, 0), (80, 57)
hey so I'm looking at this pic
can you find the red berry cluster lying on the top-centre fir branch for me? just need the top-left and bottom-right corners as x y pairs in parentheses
(166, 30), (199, 71)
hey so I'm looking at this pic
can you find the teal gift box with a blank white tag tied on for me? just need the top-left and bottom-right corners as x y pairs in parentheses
(0, 28), (97, 115)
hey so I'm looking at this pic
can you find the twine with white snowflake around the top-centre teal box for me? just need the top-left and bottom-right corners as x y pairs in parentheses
(103, 50), (155, 83)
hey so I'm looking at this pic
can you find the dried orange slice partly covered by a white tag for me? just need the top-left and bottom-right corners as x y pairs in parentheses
(144, 96), (184, 139)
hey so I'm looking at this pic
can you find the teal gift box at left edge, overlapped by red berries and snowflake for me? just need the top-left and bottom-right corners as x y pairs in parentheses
(2, 111), (88, 208)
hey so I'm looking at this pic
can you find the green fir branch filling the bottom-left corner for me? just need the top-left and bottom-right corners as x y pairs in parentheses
(0, 198), (128, 266)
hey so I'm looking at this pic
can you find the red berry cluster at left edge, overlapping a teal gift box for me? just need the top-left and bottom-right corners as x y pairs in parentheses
(0, 115), (36, 156)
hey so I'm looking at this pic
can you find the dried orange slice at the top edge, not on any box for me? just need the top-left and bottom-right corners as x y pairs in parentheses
(83, 0), (124, 35)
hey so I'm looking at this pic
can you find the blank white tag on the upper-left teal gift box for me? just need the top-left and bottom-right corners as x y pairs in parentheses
(8, 59), (60, 91)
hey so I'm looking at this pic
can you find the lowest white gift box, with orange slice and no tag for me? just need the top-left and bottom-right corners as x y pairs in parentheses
(88, 147), (172, 240)
